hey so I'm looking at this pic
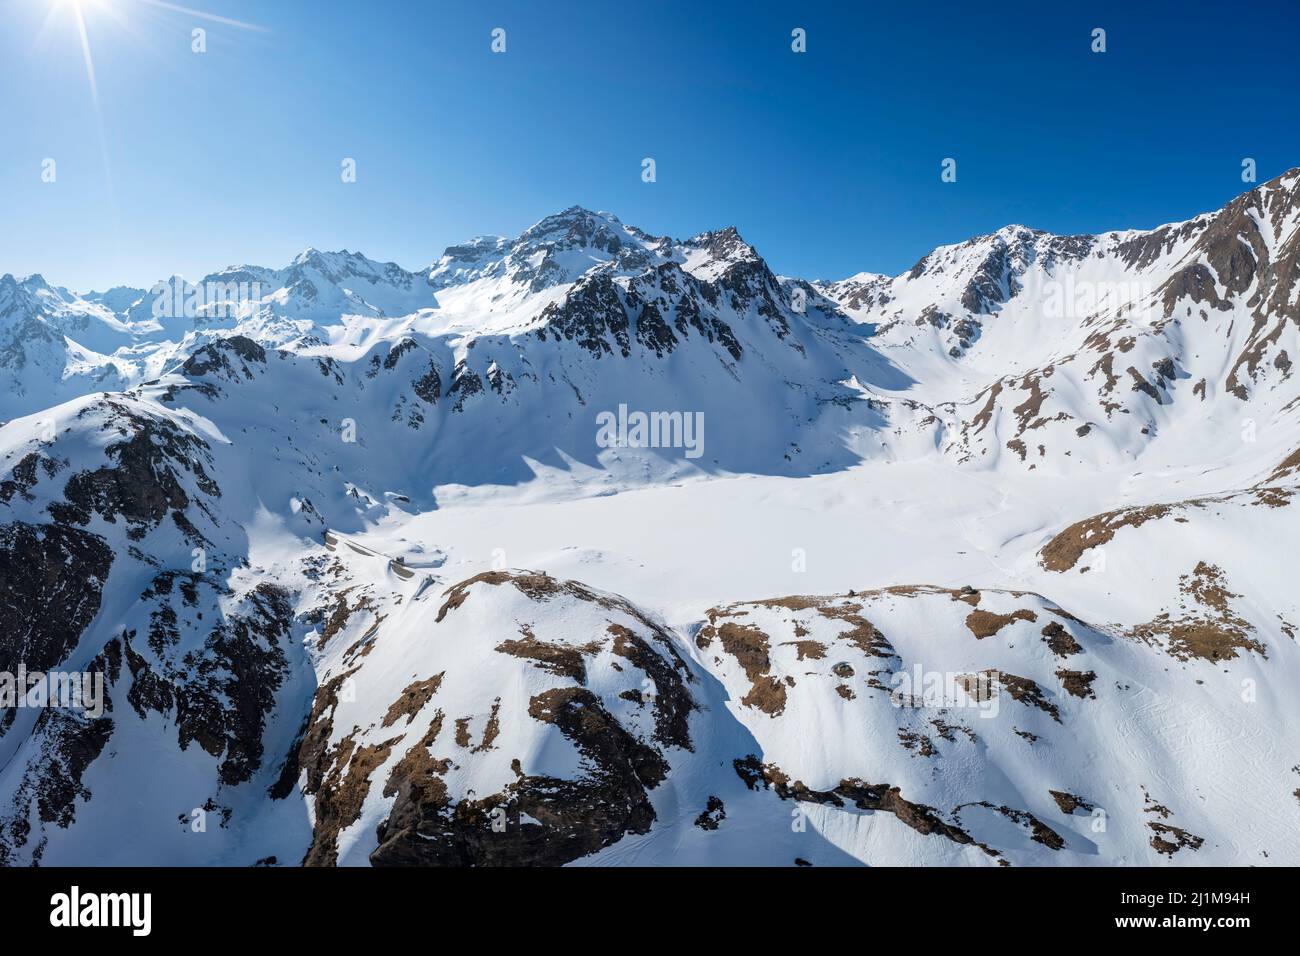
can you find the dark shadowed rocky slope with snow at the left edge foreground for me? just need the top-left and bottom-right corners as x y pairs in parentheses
(0, 395), (300, 864)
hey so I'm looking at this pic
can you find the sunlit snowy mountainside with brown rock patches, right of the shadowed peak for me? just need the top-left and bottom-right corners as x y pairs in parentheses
(820, 172), (1300, 473)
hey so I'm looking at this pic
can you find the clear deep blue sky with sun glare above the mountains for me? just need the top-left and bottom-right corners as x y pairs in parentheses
(0, 0), (1300, 290)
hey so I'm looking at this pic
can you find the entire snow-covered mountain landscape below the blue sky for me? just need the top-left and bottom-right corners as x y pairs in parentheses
(0, 170), (1300, 865)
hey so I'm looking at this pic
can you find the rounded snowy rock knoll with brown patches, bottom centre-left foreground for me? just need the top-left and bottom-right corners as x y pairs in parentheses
(289, 572), (698, 865)
